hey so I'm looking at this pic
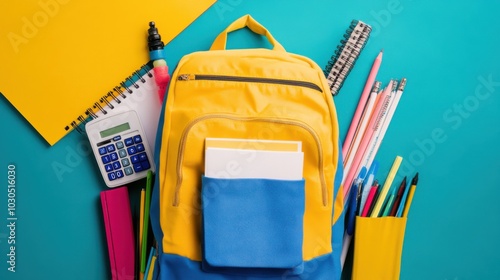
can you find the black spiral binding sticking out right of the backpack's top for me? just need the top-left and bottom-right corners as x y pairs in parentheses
(324, 20), (372, 96)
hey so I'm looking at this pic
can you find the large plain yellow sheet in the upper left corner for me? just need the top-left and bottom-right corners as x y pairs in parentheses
(0, 0), (216, 145)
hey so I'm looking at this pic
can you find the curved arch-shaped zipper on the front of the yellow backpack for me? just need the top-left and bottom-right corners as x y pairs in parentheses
(172, 114), (328, 207)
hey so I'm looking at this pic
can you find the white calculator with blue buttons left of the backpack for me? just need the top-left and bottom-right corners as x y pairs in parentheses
(85, 110), (155, 188)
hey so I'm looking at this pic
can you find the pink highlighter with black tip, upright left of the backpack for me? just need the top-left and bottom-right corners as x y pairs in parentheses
(148, 21), (170, 103)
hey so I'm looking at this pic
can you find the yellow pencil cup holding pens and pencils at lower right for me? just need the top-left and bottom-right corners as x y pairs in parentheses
(352, 217), (407, 280)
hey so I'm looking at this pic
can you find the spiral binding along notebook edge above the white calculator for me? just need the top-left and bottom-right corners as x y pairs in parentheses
(64, 63), (153, 133)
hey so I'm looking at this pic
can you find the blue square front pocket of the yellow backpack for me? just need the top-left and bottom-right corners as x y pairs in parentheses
(202, 177), (305, 269)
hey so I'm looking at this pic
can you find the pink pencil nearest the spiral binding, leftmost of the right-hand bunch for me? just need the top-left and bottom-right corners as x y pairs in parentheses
(342, 50), (384, 162)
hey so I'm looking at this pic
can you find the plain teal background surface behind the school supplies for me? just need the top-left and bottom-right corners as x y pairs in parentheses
(0, 0), (500, 280)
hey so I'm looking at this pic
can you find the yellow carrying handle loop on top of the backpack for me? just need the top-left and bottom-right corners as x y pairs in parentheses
(210, 15), (285, 52)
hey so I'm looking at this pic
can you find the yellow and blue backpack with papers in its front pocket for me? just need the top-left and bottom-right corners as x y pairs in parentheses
(151, 15), (344, 279)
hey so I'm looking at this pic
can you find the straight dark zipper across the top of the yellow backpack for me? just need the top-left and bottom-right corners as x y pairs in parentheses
(177, 74), (323, 92)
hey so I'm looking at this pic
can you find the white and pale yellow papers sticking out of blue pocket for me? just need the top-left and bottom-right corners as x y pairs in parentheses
(205, 138), (304, 180)
